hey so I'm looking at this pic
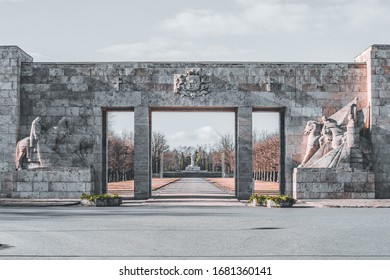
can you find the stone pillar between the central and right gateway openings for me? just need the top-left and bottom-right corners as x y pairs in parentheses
(235, 107), (253, 199)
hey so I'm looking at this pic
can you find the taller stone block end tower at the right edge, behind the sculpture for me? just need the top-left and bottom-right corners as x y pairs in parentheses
(355, 45), (390, 198)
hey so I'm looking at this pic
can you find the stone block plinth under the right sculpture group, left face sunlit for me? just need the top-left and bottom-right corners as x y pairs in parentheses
(293, 168), (375, 199)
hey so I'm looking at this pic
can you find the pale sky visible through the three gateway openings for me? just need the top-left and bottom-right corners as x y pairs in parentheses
(109, 112), (279, 148)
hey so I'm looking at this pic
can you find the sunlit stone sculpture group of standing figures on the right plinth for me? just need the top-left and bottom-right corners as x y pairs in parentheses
(298, 98), (371, 169)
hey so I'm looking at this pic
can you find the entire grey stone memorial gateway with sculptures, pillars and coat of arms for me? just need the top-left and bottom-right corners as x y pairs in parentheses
(0, 45), (390, 199)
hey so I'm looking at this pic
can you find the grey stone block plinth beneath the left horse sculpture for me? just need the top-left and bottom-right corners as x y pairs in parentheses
(12, 167), (93, 199)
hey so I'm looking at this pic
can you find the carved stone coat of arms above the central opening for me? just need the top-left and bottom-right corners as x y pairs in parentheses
(174, 68), (210, 98)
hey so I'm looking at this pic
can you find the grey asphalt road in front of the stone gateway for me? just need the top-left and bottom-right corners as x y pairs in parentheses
(0, 206), (390, 260)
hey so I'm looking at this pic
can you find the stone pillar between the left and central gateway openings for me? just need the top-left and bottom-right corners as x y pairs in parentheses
(134, 107), (152, 199)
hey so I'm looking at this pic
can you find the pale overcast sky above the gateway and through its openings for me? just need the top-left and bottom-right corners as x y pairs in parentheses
(0, 0), (390, 148)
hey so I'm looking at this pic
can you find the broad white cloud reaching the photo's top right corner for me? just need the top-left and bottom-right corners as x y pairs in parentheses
(161, 0), (390, 38)
